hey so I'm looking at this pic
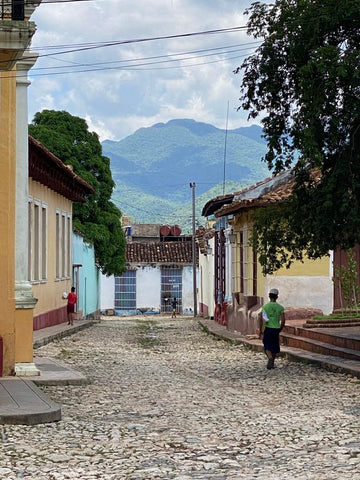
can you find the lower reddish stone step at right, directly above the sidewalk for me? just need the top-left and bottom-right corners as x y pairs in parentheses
(281, 332), (360, 361)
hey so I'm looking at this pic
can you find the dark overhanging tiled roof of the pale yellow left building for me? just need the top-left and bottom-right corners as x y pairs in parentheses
(29, 135), (95, 202)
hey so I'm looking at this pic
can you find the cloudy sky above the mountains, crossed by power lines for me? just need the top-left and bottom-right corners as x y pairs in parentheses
(29, 0), (258, 140)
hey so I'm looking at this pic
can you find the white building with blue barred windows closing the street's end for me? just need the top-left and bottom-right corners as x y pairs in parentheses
(101, 224), (194, 314)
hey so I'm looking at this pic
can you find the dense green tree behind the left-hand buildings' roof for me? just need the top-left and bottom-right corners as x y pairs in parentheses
(29, 110), (125, 275)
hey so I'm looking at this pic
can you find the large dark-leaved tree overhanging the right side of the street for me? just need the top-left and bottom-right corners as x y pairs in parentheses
(235, 0), (360, 273)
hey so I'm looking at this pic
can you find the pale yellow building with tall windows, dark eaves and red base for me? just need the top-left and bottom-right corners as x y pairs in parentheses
(28, 136), (94, 330)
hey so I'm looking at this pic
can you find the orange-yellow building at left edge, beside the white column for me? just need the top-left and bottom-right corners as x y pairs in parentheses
(0, 2), (40, 375)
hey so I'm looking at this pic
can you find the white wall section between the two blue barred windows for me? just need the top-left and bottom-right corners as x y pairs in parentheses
(136, 267), (161, 308)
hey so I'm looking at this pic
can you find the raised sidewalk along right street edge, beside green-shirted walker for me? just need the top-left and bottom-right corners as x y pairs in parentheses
(199, 319), (360, 378)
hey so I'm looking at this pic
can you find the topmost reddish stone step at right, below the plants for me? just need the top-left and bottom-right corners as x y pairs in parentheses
(283, 325), (360, 351)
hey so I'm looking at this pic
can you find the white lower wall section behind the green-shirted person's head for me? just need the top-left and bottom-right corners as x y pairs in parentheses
(264, 276), (333, 315)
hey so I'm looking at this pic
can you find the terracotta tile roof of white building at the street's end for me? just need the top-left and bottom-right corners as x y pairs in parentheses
(126, 240), (192, 264)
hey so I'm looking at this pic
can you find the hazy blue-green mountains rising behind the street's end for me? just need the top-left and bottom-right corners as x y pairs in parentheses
(102, 119), (269, 233)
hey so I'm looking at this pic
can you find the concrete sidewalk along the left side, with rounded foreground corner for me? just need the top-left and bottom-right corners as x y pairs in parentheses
(0, 320), (94, 425)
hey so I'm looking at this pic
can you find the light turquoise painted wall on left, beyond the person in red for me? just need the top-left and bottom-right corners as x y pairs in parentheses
(73, 232), (100, 317)
